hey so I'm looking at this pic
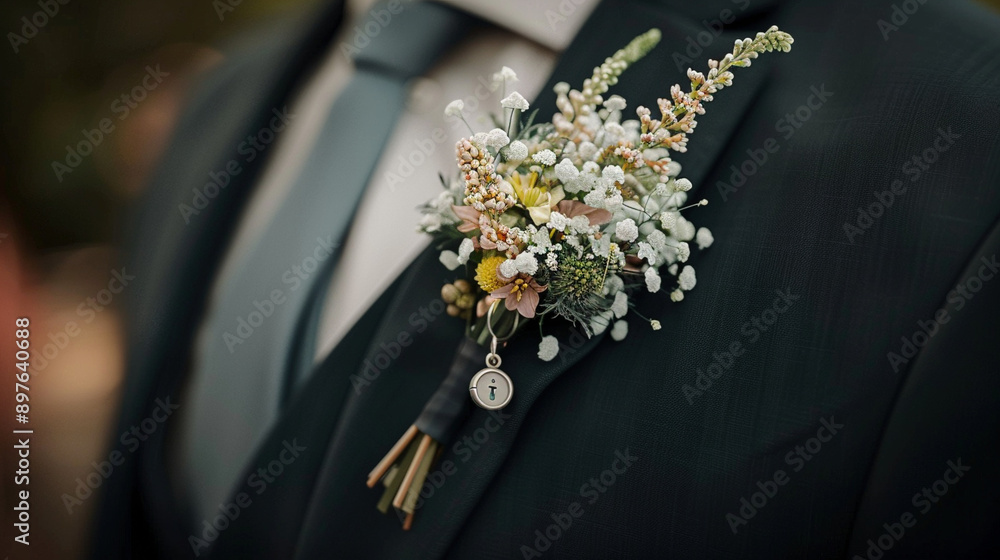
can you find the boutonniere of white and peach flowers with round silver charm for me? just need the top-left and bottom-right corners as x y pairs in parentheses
(368, 26), (793, 527)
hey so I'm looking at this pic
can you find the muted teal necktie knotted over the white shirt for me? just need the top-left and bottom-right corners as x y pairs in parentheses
(177, 3), (479, 522)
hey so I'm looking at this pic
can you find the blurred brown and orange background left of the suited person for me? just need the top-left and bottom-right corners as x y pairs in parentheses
(0, 0), (1000, 559)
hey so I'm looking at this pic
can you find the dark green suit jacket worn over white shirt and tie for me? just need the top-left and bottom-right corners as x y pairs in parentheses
(94, 0), (1000, 559)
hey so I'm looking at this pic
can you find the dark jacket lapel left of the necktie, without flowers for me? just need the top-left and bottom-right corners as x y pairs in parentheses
(98, 2), (342, 554)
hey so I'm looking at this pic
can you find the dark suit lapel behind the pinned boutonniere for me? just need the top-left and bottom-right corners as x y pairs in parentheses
(297, 2), (784, 559)
